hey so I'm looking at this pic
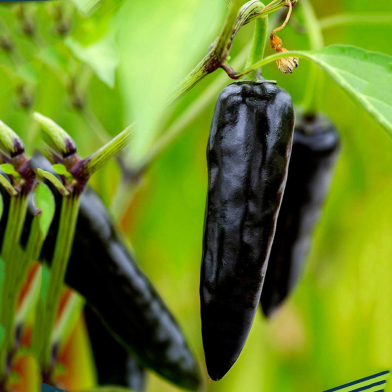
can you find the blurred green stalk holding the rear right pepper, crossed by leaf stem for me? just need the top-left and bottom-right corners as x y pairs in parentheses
(300, 0), (324, 114)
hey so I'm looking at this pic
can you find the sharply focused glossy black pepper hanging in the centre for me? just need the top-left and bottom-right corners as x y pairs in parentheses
(200, 82), (294, 380)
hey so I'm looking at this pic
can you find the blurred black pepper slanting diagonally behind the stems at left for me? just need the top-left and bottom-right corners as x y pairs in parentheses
(1, 155), (202, 390)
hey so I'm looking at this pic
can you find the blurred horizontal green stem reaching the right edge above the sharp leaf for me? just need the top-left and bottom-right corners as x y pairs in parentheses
(320, 13), (392, 30)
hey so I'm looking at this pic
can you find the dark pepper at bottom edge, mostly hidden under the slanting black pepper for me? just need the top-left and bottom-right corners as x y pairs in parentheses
(84, 305), (146, 392)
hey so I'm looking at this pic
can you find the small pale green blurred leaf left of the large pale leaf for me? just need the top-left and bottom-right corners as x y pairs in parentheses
(65, 35), (118, 87)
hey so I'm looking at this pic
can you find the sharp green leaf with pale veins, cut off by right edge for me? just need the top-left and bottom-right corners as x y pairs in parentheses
(298, 45), (392, 136)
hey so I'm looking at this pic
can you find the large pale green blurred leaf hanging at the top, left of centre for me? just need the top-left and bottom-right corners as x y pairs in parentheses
(117, 0), (227, 159)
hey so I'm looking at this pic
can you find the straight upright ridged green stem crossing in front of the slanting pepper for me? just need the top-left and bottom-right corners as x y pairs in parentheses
(35, 195), (80, 373)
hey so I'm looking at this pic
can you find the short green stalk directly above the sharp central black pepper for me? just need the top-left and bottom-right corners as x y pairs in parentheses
(244, 3), (268, 82)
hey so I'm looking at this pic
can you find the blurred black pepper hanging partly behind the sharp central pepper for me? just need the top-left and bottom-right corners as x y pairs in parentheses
(260, 114), (339, 317)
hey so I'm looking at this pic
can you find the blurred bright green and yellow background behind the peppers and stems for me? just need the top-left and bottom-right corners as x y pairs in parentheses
(0, 0), (392, 392)
